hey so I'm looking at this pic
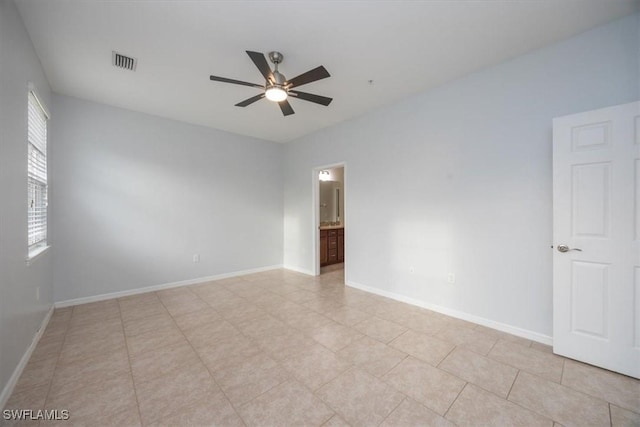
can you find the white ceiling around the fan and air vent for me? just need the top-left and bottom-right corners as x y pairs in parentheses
(15, 0), (639, 142)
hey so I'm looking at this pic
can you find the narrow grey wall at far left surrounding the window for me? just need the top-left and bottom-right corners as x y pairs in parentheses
(0, 0), (55, 406)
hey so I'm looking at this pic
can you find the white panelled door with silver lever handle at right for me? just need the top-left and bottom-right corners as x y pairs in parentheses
(553, 102), (640, 378)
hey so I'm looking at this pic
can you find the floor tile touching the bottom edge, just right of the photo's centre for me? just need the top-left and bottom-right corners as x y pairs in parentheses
(316, 368), (404, 426)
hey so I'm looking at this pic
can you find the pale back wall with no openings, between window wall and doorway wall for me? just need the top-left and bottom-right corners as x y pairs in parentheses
(51, 95), (283, 301)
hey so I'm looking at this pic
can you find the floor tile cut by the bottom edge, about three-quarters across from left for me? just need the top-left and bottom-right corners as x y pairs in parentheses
(447, 384), (553, 427)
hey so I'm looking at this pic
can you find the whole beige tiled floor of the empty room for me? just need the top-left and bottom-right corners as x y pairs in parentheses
(2, 269), (640, 426)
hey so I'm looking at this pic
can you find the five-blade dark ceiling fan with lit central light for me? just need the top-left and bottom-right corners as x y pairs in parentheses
(210, 50), (333, 116)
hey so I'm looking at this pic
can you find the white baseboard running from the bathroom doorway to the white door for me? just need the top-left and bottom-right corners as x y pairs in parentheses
(346, 281), (553, 345)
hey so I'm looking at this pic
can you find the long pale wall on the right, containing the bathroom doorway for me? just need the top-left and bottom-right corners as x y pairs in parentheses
(284, 14), (640, 336)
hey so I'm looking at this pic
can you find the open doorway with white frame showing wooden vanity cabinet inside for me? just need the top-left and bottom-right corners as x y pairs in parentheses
(312, 163), (347, 276)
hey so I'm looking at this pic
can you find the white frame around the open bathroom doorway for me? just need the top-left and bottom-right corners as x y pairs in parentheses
(311, 161), (347, 281)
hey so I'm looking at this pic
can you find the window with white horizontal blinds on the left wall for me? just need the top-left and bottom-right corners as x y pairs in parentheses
(27, 90), (49, 258)
